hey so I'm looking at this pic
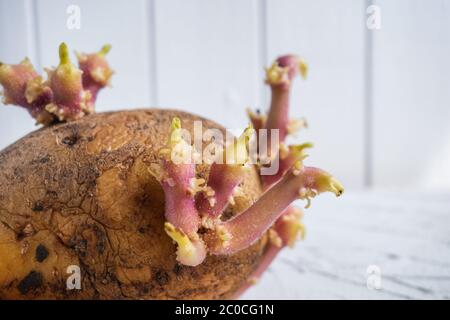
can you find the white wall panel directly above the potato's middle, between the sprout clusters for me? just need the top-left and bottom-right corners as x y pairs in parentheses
(155, 0), (263, 128)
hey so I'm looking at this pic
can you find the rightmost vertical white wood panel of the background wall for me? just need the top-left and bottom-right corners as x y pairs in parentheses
(373, 0), (450, 189)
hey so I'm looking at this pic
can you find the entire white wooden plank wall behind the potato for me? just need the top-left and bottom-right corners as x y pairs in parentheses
(0, 0), (450, 190)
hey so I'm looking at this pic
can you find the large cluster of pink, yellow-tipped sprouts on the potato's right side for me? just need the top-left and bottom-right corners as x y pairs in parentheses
(150, 55), (343, 268)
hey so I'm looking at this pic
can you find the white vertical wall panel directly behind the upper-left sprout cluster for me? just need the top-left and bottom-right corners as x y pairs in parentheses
(33, 0), (151, 111)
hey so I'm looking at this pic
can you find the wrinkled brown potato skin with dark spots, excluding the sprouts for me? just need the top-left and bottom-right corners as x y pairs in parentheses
(0, 109), (266, 299)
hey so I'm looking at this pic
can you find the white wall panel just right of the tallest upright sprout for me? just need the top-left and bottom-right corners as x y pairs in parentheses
(267, 0), (366, 187)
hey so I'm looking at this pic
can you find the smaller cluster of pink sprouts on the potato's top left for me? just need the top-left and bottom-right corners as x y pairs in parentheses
(0, 43), (113, 125)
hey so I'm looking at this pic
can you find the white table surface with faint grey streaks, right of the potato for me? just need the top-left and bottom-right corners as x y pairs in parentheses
(242, 191), (450, 299)
